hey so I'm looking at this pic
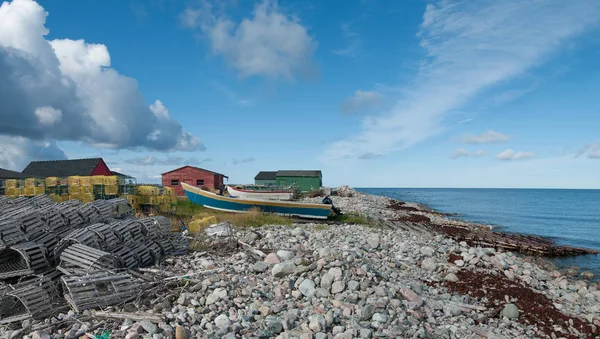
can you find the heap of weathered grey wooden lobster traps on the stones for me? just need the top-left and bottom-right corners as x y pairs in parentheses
(0, 195), (187, 324)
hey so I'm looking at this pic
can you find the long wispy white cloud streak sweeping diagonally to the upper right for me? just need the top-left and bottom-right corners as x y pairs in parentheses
(321, 0), (600, 162)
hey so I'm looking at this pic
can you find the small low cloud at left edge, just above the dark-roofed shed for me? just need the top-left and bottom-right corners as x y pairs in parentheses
(0, 135), (67, 172)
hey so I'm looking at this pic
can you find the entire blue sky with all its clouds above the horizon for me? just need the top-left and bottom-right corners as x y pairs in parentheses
(0, 0), (600, 189)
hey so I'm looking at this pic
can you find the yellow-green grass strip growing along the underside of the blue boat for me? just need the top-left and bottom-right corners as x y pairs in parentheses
(169, 200), (292, 227)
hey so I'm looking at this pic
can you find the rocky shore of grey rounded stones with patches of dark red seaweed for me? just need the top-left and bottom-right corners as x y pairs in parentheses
(0, 188), (600, 339)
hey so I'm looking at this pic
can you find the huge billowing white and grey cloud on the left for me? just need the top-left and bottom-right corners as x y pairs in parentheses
(0, 0), (204, 156)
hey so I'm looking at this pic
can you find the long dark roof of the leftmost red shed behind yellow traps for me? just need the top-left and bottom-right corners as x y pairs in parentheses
(23, 158), (103, 177)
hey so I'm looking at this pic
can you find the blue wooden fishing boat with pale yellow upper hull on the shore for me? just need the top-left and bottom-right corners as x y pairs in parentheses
(181, 183), (332, 219)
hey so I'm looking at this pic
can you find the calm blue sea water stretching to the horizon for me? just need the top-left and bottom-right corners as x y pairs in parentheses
(358, 188), (600, 276)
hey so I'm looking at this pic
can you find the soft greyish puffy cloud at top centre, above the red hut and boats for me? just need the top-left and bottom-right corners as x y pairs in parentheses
(181, 0), (317, 79)
